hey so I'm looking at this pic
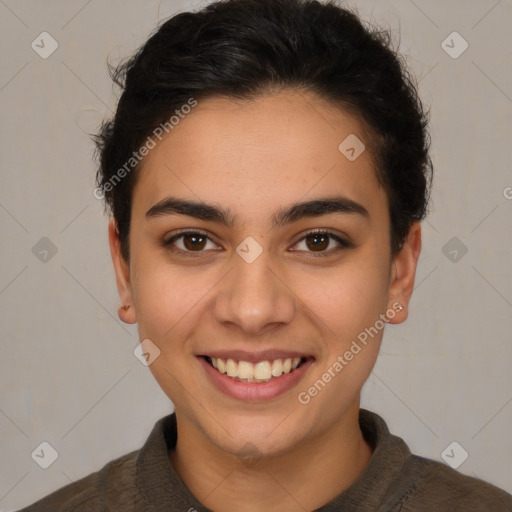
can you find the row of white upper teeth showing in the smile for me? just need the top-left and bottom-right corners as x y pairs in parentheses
(210, 357), (300, 381)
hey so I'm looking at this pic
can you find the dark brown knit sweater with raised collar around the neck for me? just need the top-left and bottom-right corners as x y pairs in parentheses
(20, 409), (512, 512)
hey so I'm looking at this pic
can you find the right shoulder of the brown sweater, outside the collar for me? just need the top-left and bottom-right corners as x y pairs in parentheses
(398, 455), (512, 512)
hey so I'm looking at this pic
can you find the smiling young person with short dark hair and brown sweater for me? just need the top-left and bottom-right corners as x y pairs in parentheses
(19, 0), (512, 512)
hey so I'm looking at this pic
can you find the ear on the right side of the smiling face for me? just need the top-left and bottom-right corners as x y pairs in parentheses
(388, 222), (421, 324)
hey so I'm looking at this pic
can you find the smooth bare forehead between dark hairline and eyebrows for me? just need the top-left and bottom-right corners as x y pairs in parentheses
(133, 91), (386, 224)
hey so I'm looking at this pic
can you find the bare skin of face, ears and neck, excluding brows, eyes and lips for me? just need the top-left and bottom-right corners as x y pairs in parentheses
(109, 90), (421, 512)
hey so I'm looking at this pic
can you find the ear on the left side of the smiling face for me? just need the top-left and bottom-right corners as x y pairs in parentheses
(108, 218), (137, 324)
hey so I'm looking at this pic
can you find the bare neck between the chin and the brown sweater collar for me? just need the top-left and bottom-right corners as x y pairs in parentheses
(169, 400), (371, 512)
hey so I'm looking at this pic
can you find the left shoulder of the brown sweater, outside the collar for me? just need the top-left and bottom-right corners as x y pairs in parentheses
(19, 450), (139, 512)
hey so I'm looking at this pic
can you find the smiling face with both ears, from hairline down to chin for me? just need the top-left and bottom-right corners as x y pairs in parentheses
(110, 91), (419, 455)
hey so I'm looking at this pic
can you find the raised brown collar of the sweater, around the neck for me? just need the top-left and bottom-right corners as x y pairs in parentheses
(136, 409), (414, 512)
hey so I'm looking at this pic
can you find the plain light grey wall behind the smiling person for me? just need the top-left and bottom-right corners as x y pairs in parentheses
(0, 0), (512, 511)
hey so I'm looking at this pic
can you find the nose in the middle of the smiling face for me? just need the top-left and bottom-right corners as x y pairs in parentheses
(213, 247), (297, 336)
